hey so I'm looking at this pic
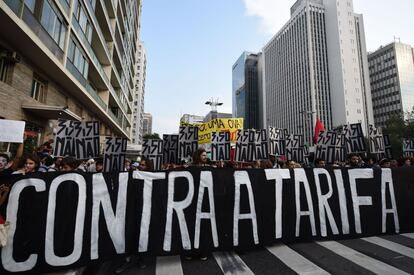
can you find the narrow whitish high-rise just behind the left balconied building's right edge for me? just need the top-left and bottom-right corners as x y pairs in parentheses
(131, 42), (147, 144)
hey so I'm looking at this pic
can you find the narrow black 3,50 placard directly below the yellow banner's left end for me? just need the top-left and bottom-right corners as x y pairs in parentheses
(178, 126), (198, 160)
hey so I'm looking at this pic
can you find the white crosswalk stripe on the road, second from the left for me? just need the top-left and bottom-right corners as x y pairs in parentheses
(213, 252), (254, 275)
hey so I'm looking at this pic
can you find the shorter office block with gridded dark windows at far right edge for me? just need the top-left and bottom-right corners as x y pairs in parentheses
(368, 42), (414, 127)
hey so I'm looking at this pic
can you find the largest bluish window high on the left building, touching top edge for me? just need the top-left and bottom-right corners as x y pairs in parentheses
(40, 0), (67, 49)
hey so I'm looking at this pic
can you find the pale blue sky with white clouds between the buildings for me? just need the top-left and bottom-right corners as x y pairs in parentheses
(141, 0), (414, 135)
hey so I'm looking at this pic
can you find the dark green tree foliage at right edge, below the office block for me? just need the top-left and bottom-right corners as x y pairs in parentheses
(383, 108), (414, 158)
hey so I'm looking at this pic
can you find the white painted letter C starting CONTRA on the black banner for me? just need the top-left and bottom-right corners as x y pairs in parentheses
(1, 179), (46, 272)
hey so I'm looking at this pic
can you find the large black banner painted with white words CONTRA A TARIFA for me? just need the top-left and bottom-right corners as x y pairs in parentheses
(0, 167), (414, 274)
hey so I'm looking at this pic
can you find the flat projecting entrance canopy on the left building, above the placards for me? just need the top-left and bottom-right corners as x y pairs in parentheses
(22, 105), (82, 121)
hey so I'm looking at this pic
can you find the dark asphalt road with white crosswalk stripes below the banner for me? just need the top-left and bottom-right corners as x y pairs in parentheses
(88, 233), (414, 275)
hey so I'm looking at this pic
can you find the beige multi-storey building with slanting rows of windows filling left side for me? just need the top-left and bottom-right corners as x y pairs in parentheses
(0, 0), (141, 150)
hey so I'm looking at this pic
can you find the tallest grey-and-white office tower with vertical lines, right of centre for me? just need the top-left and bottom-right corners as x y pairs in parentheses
(263, 0), (373, 143)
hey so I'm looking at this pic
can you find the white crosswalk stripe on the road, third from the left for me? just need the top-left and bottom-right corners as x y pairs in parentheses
(267, 244), (329, 275)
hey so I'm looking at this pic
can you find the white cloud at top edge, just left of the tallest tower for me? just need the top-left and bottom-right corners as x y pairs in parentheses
(243, 0), (294, 34)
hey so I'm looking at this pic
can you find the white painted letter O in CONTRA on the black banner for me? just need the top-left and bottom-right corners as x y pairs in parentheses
(45, 173), (86, 266)
